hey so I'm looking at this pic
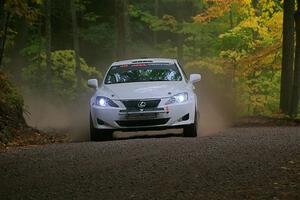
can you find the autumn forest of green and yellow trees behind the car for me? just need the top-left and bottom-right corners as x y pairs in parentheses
(0, 0), (300, 141)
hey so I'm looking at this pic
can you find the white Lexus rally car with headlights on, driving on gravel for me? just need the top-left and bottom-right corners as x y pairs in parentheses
(88, 58), (201, 140)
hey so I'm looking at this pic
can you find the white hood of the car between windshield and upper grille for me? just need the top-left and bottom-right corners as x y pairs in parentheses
(97, 81), (187, 99)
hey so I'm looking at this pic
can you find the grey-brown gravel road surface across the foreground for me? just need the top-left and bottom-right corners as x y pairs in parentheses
(0, 127), (300, 200)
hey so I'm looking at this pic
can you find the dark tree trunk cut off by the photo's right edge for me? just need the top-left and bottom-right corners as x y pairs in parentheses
(290, 0), (300, 117)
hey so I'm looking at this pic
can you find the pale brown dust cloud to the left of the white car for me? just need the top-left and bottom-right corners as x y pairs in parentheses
(24, 94), (89, 141)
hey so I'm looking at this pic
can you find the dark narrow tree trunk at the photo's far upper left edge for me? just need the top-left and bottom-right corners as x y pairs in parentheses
(0, 0), (9, 69)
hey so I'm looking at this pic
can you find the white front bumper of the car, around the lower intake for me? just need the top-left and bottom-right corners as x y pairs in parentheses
(91, 101), (196, 130)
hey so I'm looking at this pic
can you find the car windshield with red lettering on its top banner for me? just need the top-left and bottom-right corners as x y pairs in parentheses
(105, 63), (182, 84)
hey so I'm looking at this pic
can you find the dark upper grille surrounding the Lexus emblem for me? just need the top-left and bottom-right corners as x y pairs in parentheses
(122, 99), (161, 111)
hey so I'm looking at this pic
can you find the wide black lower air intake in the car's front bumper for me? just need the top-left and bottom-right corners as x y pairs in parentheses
(116, 118), (170, 127)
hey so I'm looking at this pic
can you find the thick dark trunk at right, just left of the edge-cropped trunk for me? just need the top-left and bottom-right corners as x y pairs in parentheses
(280, 0), (295, 114)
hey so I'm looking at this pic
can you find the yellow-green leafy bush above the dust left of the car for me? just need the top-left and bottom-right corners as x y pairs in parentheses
(22, 50), (101, 101)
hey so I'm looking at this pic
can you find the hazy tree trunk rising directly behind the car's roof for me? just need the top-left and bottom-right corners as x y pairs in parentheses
(115, 0), (127, 59)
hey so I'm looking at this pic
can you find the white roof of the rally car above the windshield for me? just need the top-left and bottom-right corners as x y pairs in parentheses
(112, 58), (177, 66)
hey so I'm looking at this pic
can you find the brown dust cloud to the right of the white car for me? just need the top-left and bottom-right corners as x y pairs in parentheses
(189, 70), (236, 136)
